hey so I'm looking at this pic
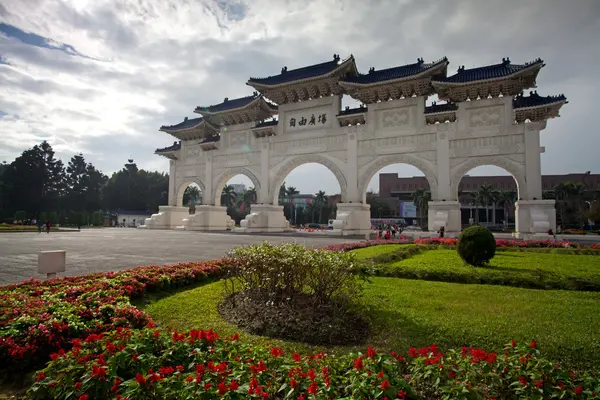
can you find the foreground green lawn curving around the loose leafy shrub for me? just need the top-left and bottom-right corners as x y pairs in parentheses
(145, 278), (600, 367)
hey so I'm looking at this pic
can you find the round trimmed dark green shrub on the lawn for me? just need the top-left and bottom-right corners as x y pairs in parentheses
(456, 225), (496, 266)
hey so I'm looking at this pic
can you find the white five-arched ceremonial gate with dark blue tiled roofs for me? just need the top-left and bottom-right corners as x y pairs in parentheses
(146, 55), (566, 236)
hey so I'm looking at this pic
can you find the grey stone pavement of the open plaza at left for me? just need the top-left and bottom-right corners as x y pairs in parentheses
(0, 228), (357, 285)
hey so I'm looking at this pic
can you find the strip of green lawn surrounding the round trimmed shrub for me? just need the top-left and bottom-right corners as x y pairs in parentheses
(377, 249), (600, 291)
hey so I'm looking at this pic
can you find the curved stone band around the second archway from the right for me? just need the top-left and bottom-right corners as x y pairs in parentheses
(358, 154), (438, 203)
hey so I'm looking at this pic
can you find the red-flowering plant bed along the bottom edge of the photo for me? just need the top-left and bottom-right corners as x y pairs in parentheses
(28, 328), (600, 400)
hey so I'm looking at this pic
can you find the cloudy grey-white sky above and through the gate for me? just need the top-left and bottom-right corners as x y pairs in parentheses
(0, 0), (600, 193)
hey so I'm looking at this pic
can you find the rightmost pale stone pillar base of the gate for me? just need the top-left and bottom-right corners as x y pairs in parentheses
(515, 200), (556, 238)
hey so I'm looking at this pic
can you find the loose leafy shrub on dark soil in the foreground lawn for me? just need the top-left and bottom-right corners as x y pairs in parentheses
(219, 243), (368, 344)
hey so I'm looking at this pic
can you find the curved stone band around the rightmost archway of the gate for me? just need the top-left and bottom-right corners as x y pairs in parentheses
(450, 156), (528, 200)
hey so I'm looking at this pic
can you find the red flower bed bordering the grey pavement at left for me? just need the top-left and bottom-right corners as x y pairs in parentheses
(0, 260), (224, 378)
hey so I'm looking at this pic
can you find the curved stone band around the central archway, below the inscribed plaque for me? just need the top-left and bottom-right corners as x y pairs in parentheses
(268, 154), (348, 204)
